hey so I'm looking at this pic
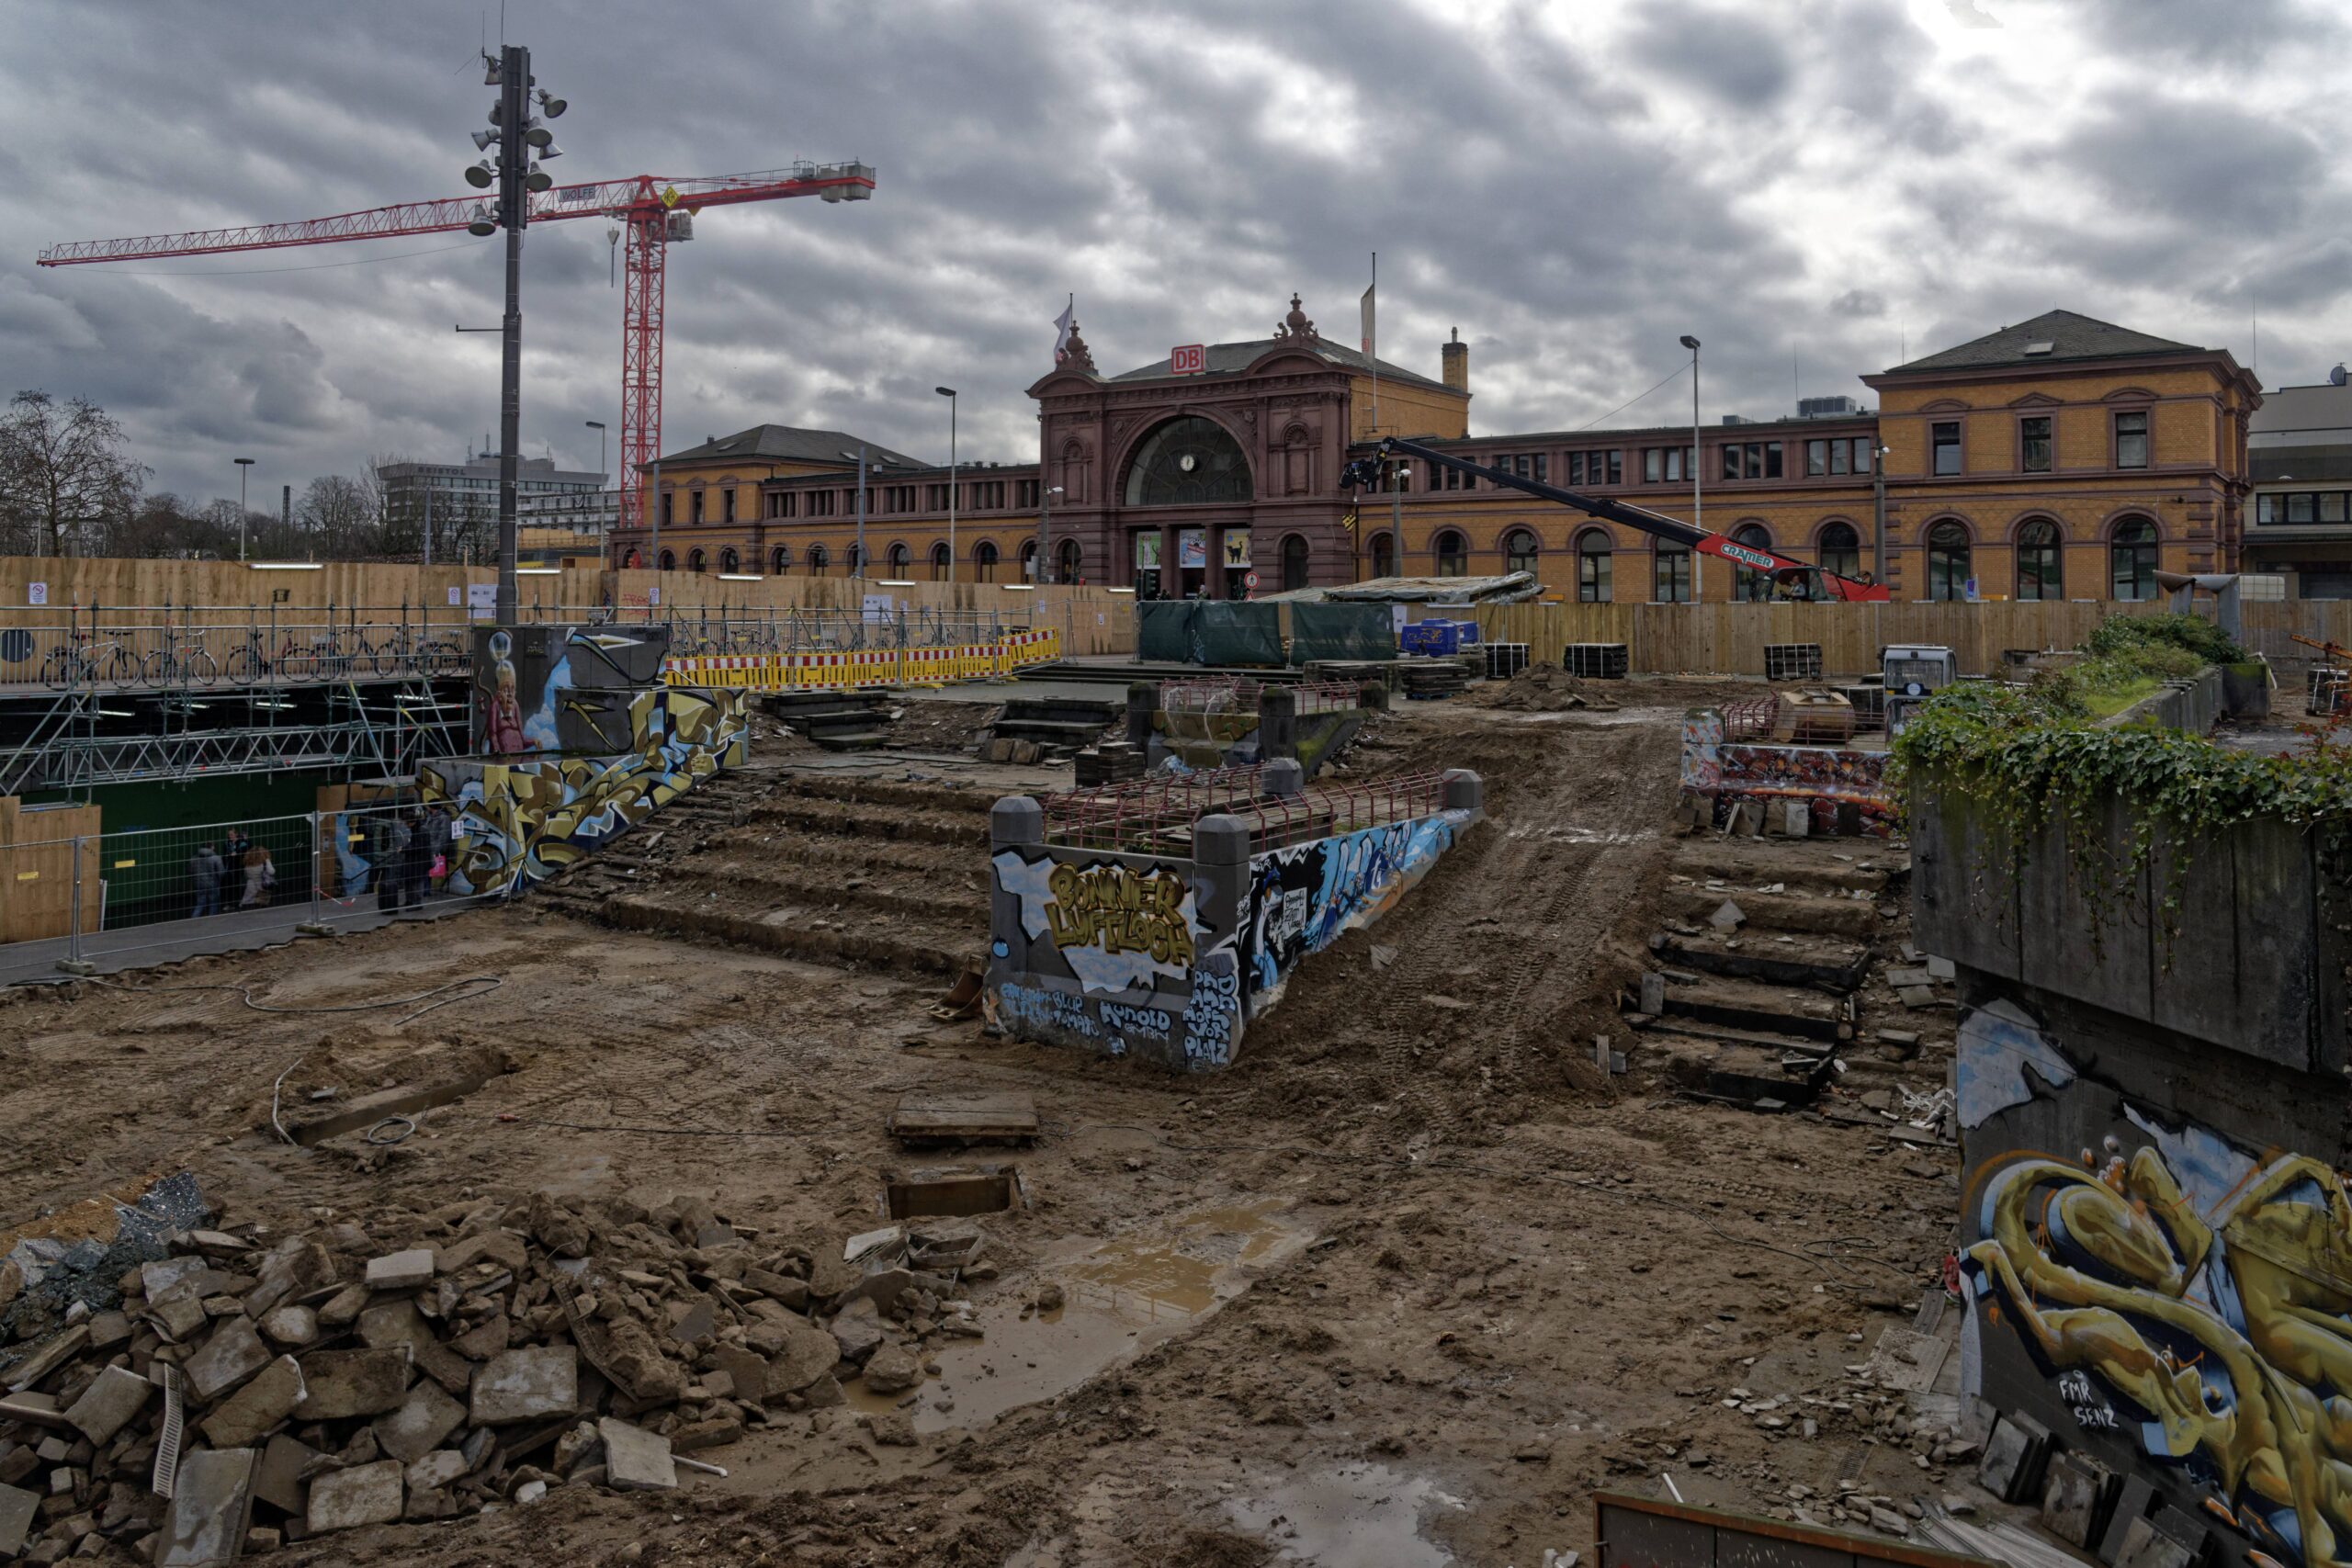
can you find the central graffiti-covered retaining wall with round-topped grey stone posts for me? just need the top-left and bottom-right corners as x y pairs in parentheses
(988, 761), (1482, 1072)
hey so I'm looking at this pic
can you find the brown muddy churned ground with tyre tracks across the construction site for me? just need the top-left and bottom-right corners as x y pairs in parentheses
(0, 682), (1954, 1568)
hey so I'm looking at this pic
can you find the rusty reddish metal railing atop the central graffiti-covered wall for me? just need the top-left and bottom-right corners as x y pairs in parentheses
(1040, 764), (1444, 853)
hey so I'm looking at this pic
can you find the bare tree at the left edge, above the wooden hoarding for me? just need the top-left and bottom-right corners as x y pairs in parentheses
(0, 390), (148, 555)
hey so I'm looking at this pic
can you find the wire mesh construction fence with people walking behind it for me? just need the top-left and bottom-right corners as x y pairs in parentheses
(0, 802), (503, 962)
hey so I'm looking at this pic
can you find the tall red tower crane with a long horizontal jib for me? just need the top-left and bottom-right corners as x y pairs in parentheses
(40, 163), (875, 545)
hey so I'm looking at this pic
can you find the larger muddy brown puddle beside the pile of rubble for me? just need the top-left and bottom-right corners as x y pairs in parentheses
(842, 1199), (1315, 1432)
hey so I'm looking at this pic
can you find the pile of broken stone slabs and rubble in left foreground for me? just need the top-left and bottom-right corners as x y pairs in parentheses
(0, 1192), (992, 1565)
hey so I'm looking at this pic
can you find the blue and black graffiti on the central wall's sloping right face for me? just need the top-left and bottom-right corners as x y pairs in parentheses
(1247, 811), (1461, 1009)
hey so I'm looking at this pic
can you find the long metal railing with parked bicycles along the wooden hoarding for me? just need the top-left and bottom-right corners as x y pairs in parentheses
(0, 604), (1033, 694)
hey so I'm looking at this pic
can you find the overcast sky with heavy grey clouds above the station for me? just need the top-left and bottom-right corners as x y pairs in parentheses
(0, 0), (2352, 503)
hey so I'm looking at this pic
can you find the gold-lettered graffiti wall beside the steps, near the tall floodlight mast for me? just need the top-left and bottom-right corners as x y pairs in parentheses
(416, 682), (751, 894)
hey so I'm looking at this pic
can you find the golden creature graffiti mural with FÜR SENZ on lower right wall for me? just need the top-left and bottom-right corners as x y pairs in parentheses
(1959, 1001), (2352, 1568)
